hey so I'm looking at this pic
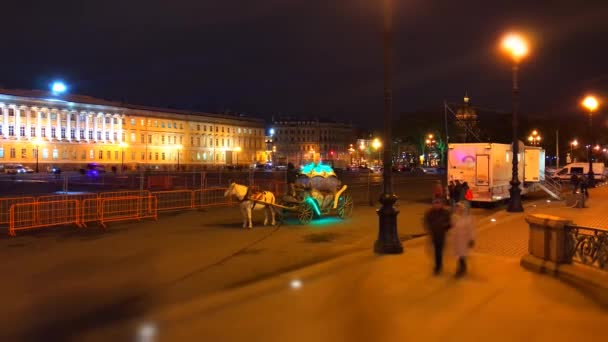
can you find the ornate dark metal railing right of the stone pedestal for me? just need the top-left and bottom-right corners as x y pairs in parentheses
(566, 225), (608, 271)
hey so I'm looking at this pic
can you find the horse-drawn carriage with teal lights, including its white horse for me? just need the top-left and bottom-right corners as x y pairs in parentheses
(225, 164), (353, 228)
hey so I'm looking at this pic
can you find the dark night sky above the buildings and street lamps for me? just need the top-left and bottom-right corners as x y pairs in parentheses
(0, 0), (608, 125)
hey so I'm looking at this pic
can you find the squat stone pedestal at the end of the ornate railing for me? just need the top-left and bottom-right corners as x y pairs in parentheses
(526, 214), (572, 265)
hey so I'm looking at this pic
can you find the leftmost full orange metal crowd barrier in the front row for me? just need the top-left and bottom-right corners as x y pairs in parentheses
(8, 200), (80, 236)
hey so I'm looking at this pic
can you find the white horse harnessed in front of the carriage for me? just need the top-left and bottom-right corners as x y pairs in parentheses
(224, 182), (276, 229)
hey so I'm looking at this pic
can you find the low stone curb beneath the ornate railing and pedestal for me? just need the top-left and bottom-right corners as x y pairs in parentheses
(520, 254), (608, 309)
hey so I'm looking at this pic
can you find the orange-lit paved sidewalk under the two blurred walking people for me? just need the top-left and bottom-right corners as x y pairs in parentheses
(88, 187), (608, 341)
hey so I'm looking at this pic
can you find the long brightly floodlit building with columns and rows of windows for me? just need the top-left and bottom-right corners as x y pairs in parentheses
(0, 89), (265, 171)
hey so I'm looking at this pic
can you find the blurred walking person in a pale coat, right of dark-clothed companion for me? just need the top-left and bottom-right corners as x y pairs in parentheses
(452, 203), (475, 278)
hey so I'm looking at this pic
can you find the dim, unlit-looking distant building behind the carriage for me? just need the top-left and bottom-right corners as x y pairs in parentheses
(270, 118), (355, 165)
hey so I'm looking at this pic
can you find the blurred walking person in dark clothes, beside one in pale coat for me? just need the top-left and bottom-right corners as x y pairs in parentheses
(424, 199), (451, 275)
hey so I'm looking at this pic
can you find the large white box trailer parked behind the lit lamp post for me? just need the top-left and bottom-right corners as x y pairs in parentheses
(447, 142), (545, 202)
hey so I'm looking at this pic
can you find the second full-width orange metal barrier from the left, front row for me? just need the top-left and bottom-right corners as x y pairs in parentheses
(99, 196), (158, 227)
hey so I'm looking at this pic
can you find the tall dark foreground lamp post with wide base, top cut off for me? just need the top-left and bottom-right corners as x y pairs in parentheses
(374, 0), (403, 254)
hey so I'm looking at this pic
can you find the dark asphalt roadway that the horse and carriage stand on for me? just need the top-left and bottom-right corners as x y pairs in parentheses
(0, 178), (504, 341)
